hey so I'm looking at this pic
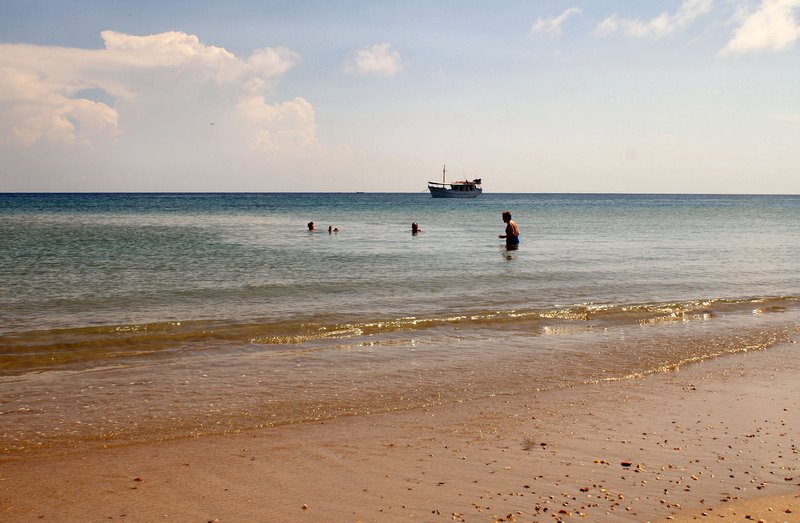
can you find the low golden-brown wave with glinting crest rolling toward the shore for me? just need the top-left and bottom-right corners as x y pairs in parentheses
(0, 297), (800, 375)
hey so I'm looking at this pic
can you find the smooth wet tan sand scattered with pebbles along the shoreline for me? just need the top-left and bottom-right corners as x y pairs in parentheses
(0, 343), (800, 522)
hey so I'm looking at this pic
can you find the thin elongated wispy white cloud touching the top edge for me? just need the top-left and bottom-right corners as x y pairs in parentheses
(595, 0), (713, 40)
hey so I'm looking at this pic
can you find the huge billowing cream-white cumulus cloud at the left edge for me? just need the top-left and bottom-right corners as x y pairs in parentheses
(0, 31), (315, 154)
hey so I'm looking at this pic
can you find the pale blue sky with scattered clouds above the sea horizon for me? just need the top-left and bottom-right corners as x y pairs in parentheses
(0, 0), (800, 194)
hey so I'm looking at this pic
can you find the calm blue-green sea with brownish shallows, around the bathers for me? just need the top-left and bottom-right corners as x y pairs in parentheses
(0, 193), (800, 458)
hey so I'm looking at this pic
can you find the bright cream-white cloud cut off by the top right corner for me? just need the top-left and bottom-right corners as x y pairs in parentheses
(722, 0), (800, 54)
